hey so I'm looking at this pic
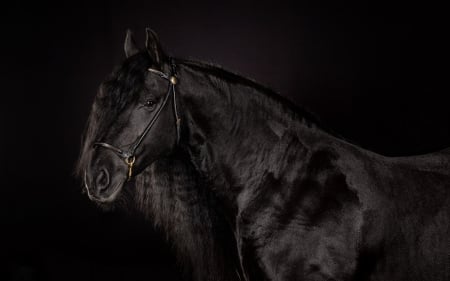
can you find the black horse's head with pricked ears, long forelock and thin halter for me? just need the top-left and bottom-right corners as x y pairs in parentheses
(78, 29), (180, 203)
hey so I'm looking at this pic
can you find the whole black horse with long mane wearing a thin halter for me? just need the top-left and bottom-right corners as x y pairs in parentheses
(78, 30), (450, 280)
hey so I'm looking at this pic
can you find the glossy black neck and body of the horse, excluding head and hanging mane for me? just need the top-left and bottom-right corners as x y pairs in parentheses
(174, 60), (450, 280)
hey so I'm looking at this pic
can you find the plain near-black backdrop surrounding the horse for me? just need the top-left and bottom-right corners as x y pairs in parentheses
(0, 1), (450, 281)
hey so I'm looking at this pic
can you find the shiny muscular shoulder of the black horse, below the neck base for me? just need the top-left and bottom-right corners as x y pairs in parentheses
(237, 144), (363, 280)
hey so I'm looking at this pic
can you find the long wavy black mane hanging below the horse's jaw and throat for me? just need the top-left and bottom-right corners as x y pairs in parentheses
(132, 153), (239, 281)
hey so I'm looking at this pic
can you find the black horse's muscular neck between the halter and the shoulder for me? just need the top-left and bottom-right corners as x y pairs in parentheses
(179, 61), (324, 212)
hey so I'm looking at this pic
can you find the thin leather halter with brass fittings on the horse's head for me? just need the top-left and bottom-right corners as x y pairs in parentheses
(94, 58), (181, 180)
